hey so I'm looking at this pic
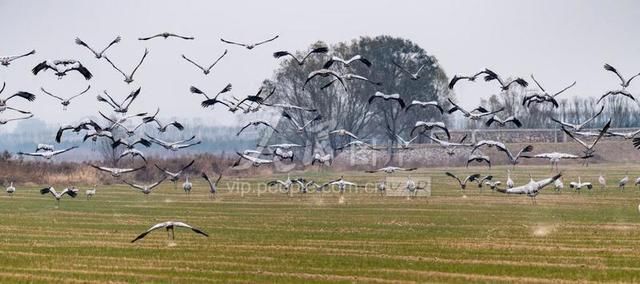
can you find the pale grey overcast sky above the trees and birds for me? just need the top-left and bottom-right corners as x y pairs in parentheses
(0, 0), (640, 130)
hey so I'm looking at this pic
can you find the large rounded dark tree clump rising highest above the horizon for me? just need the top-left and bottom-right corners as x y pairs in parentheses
(270, 36), (449, 164)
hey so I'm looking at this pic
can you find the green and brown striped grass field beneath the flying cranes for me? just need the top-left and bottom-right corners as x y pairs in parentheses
(0, 165), (640, 283)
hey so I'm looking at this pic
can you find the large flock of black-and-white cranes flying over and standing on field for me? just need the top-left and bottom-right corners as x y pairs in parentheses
(0, 33), (640, 241)
